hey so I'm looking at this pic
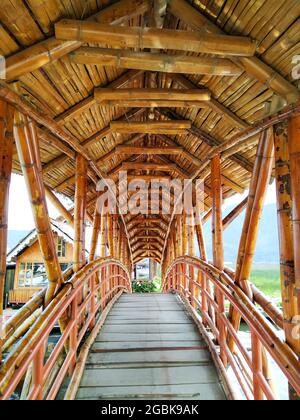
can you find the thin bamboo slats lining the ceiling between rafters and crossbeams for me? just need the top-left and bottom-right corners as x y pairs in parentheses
(0, 0), (300, 260)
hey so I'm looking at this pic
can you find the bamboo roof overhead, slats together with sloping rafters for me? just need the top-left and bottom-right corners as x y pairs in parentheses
(0, 0), (300, 262)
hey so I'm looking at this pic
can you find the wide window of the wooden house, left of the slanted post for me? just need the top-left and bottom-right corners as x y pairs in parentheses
(19, 262), (47, 288)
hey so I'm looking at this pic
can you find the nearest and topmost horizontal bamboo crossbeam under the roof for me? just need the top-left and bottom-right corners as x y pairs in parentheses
(55, 19), (257, 57)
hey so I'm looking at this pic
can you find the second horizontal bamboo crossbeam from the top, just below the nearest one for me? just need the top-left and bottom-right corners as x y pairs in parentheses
(70, 47), (242, 77)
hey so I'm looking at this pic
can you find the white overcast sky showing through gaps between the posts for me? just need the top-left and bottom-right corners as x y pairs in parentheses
(8, 175), (276, 230)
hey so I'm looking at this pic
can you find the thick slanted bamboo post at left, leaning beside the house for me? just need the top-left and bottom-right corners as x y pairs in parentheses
(14, 112), (63, 305)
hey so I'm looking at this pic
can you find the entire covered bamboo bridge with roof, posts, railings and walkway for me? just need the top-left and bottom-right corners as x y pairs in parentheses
(0, 0), (300, 400)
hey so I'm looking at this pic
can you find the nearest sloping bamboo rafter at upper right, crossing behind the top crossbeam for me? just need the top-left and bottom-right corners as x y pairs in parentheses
(168, 0), (300, 103)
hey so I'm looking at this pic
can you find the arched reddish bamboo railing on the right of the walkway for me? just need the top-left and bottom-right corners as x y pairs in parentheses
(163, 256), (300, 400)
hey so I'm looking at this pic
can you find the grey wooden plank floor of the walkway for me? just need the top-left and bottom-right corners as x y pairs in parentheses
(77, 294), (225, 400)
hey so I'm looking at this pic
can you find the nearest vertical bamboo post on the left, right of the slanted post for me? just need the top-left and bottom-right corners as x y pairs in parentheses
(74, 155), (87, 273)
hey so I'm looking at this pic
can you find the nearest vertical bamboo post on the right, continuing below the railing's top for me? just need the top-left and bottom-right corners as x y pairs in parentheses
(211, 156), (227, 366)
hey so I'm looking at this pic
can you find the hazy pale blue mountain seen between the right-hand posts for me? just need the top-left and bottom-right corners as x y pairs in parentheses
(204, 204), (280, 263)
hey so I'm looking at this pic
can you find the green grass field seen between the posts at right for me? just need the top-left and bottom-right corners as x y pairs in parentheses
(251, 264), (281, 305)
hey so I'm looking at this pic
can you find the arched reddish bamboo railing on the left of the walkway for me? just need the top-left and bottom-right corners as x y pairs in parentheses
(0, 258), (132, 400)
